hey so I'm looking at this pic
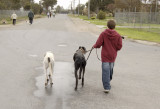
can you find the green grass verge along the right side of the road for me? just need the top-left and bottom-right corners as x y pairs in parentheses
(70, 15), (160, 43)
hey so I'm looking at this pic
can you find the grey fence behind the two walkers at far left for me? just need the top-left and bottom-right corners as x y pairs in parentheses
(0, 10), (29, 19)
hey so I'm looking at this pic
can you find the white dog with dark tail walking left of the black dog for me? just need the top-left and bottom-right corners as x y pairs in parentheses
(43, 51), (55, 86)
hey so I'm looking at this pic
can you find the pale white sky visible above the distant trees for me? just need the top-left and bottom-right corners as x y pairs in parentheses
(34, 0), (88, 9)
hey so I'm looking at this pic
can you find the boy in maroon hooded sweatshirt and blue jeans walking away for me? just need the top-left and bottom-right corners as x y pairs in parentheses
(93, 20), (122, 93)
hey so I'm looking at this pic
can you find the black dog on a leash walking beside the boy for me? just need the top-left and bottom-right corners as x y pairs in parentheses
(73, 46), (87, 90)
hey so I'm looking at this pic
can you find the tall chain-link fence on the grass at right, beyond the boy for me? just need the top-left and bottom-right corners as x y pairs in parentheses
(115, 12), (160, 33)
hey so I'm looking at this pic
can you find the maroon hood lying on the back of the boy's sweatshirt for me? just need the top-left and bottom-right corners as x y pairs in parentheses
(104, 29), (117, 40)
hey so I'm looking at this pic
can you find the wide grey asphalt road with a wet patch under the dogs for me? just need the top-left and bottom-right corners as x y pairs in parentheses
(0, 15), (160, 109)
